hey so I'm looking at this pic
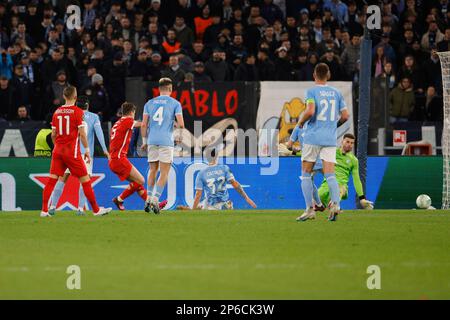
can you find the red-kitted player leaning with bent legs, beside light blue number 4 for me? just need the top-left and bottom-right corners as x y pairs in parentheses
(108, 102), (167, 211)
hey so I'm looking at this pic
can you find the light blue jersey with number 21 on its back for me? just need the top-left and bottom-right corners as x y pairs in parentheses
(303, 85), (346, 147)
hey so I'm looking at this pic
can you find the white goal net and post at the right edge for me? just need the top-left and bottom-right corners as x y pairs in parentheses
(438, 51), (450, 209)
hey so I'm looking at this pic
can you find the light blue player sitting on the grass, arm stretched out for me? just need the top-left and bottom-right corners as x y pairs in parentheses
(192, 149), (256, 210)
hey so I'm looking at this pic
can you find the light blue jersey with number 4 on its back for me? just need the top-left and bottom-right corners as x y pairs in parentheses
(144, 96), (183, 147)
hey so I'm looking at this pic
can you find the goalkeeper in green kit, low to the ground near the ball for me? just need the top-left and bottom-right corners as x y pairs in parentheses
(318, 133), (373, 210)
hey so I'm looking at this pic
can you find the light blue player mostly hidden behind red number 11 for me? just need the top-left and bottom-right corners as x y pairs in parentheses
(49, 96), (109, 215)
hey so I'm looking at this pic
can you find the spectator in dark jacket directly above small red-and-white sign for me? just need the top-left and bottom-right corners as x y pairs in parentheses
(389, 78), (415, 124)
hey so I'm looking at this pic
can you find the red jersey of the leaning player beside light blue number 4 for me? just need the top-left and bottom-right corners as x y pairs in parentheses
(109, 117), (134, 159)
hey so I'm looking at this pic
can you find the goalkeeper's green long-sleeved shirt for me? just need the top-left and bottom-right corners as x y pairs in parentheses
(335, 148), (364, 197)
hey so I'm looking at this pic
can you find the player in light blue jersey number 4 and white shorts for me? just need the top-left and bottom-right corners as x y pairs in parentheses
(141, 78), (184, 214)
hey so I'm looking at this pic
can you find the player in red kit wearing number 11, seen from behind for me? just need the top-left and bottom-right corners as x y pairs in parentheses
(41, 86), (111, 217)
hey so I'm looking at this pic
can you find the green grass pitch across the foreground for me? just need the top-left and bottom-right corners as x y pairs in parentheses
(0, 210), (450, 299)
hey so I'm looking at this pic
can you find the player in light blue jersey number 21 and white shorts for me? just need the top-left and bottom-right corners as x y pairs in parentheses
(297, 63), (349, 221)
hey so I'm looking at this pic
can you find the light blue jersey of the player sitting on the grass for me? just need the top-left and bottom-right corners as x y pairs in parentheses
(195, 164), (234, 206)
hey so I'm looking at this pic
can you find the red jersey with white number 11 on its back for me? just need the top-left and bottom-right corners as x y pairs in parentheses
(52, 106), (84, 158)
